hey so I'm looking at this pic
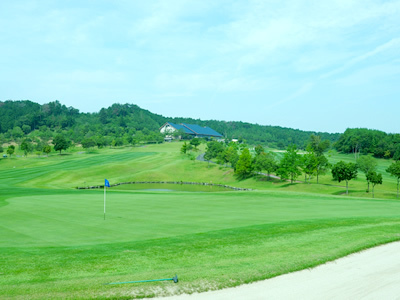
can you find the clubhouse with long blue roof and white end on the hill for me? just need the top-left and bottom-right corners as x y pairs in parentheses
(160, 122), (222, 140)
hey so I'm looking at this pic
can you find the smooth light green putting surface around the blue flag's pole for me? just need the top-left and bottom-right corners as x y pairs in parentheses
(0, 190), (400, 247)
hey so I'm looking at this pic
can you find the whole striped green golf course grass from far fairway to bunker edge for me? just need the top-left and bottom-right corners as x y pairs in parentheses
(0, 143), (400, 299)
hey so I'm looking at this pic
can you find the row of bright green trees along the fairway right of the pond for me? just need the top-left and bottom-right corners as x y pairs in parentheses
(191, 135), (400, 197)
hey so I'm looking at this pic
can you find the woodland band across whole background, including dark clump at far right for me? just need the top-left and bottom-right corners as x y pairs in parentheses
(0, 100), (400, 159)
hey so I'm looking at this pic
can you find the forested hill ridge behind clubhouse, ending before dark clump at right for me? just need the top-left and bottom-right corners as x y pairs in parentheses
(0, 100), (340, 149)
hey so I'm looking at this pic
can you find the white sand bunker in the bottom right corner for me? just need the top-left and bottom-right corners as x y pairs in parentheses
(155, 242), (400, 300)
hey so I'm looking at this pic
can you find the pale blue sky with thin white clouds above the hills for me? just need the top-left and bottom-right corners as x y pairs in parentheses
(0, 0), (400, 133)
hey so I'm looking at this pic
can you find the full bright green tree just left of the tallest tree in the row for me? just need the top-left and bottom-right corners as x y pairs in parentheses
(277, 145), (301, 184)
